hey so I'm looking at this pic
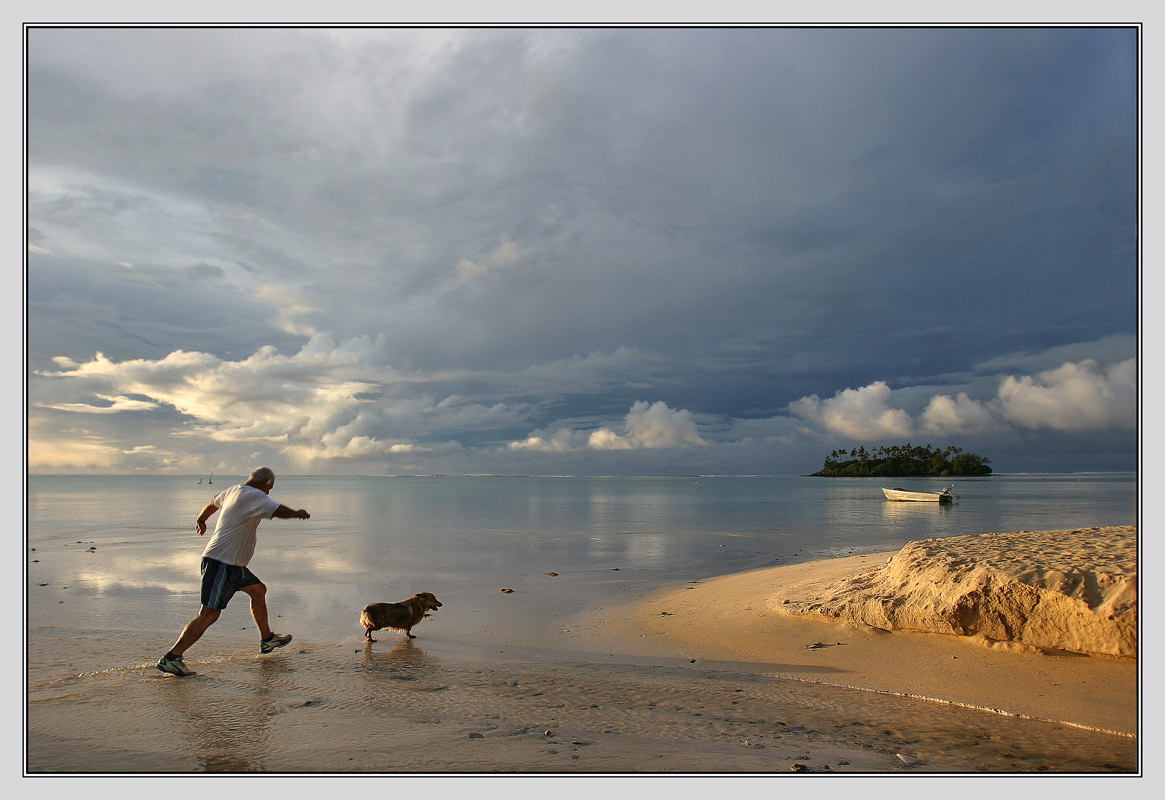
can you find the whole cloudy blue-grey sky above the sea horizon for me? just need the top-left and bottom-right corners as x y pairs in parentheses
(26, 28), (1138, 475)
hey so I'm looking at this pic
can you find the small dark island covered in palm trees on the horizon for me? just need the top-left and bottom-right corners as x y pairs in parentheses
(812, 444), (991, 477)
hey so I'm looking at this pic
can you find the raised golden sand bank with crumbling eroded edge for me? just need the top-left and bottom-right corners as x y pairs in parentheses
(769, 525), (1137, 658)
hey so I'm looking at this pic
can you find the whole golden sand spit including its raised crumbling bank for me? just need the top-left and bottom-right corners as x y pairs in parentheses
(591, 526), (1137, 735)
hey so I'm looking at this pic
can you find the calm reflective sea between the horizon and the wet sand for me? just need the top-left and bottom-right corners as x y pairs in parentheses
(27, 474), (1137, 659)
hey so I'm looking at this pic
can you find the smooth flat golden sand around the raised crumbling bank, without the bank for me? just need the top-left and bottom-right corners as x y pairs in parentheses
(574, 529), (1138, 737)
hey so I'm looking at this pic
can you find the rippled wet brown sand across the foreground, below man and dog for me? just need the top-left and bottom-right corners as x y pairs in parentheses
(28, 637), (1136, 774)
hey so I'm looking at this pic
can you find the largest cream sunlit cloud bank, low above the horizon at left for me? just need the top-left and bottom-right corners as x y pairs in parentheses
(36, 334), (529, 463)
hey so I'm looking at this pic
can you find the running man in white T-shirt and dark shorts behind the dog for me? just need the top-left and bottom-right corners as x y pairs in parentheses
(157, 467), (311, 678)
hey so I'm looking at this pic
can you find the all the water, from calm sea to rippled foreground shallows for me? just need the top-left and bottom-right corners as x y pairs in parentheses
(27, 475), (1137, 773)
